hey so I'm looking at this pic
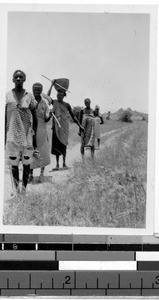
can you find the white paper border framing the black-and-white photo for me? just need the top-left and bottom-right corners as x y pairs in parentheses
(0, 2), (159, 235)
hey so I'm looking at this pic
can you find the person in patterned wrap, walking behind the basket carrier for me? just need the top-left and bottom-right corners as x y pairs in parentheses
(79, 98), (95, 158)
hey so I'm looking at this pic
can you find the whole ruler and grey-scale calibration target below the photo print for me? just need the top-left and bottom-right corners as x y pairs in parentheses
(0, 234), (159, 296)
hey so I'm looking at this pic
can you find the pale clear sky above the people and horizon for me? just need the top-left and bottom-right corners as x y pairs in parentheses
(6, 11), (150, 113)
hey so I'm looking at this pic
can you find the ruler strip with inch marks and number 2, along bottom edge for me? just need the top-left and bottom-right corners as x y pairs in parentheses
(0, 271), (159, 296)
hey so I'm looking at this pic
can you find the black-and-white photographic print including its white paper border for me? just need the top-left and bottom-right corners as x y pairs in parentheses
(1, 4), (156, 233)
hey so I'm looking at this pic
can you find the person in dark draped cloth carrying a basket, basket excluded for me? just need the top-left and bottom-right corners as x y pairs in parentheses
(47, 80), (83, 170)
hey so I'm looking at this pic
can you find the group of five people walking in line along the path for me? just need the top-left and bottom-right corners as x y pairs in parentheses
(5, 70), (103, 194)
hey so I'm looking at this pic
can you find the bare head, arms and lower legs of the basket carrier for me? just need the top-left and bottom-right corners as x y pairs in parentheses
(47, 80), (84, 169)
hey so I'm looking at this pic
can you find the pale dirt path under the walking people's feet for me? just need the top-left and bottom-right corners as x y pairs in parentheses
(4, 127), (127, 201)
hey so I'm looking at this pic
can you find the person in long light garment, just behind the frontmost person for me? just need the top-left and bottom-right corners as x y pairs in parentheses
(29, 82), (52, 182)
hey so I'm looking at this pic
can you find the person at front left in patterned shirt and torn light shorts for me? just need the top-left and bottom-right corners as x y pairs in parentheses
(5, 70), (37, 194)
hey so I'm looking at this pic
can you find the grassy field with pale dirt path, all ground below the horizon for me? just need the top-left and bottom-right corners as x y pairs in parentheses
(4, 116), (148, 228)
